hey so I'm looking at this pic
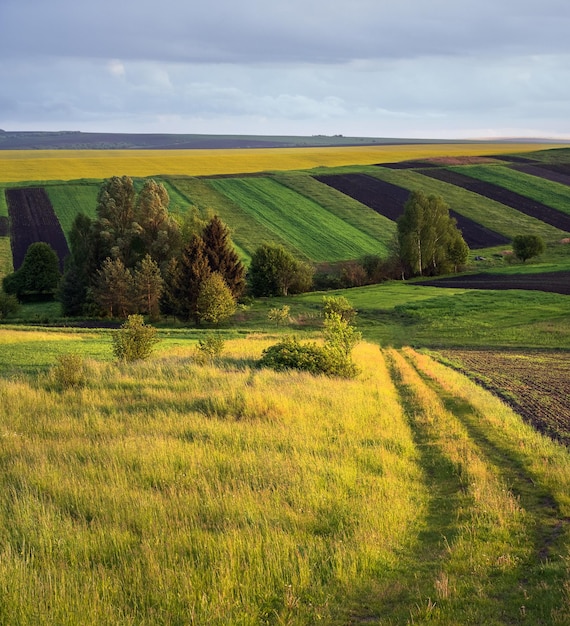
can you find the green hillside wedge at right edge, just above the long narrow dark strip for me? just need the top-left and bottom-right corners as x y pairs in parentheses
(447, 165), (570, 215)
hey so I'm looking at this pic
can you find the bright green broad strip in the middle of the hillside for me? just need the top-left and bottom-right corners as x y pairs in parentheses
(210, 177), (378, 262)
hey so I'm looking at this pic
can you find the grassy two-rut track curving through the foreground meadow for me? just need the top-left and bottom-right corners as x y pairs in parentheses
(350, 349), (570, 625)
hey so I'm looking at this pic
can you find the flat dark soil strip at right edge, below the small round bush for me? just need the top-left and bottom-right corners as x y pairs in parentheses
(417, 271), (570, 296)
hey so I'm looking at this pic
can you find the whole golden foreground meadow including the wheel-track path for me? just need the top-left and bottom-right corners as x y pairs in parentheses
(0, 331), (570, 625)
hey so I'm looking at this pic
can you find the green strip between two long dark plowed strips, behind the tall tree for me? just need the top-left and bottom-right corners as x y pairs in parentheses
(366, 167), (565, 241)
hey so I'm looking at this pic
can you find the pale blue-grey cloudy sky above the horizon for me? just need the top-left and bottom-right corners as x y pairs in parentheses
(0, 0), (570, 139)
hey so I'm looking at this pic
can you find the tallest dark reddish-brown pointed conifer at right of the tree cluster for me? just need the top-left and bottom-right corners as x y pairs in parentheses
(202, 215), (245, 298)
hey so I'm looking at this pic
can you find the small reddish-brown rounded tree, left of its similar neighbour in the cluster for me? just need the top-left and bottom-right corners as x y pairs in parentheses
(93, 258), (136, 317)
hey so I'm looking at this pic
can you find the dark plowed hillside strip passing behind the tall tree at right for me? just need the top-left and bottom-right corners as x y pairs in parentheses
(315, 173), (510, 250)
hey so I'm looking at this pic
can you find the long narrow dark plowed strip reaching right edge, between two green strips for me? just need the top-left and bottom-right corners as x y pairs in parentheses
(421, 169), (570, 232)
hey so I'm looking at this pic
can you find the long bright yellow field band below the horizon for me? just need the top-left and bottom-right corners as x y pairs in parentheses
(0, 143), (553, 182)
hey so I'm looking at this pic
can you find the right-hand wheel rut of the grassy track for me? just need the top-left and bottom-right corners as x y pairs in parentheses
(404, 352), (570, 624)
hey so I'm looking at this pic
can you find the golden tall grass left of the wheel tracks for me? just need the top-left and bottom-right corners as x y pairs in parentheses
(0, 339), (424, 625)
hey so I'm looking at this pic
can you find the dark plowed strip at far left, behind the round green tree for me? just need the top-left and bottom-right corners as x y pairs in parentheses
(6, 187), (69, 271)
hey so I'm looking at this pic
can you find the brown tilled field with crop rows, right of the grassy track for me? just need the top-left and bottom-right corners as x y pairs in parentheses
(440, 349), (570, 444)
